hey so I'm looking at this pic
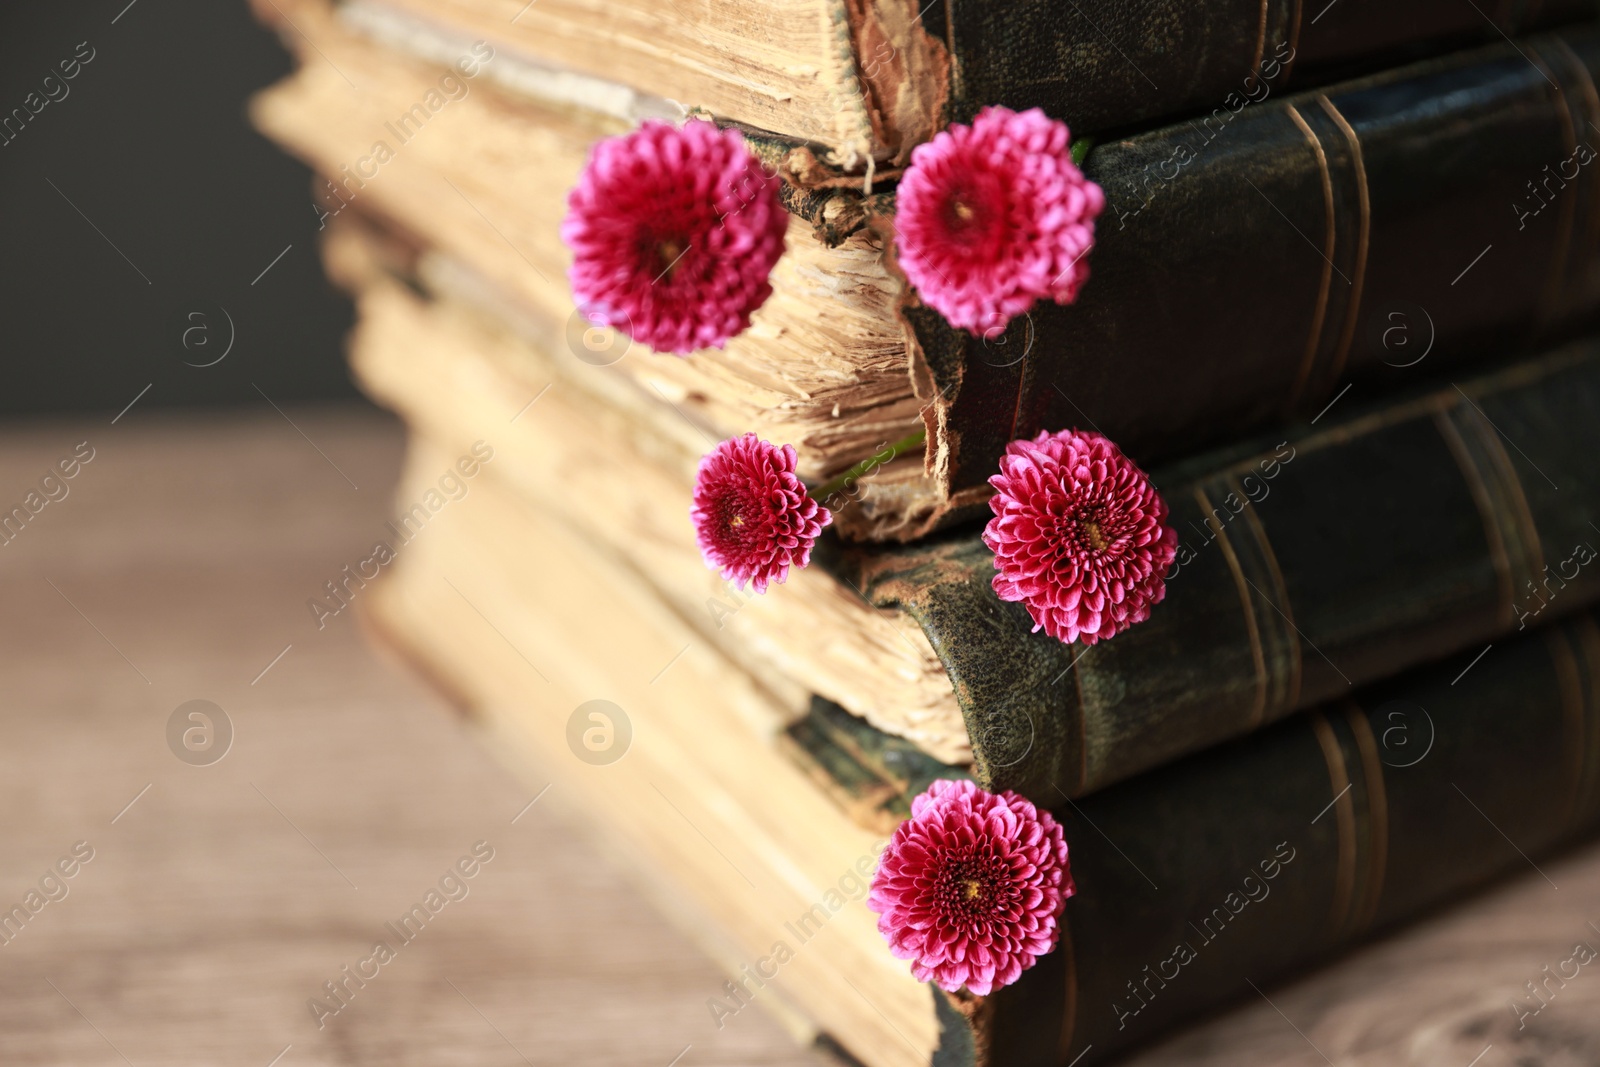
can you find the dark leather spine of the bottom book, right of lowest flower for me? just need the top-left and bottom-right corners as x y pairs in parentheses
(800, 613), (1600, 1067)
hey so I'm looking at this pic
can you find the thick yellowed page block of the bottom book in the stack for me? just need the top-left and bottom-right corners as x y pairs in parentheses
(355, 437), (939, 1067)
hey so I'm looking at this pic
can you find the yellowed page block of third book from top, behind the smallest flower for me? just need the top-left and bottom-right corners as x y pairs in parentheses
(325, 219), (971, 765)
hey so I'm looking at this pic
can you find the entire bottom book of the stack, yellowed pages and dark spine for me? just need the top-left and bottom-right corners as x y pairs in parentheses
(360, 428), (1600, 1067)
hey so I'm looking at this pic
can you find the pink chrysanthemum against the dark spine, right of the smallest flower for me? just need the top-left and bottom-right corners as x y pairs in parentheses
(984, 430), (1178, 645)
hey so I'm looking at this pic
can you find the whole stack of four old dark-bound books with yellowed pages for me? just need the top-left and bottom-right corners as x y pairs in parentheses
(253, 0), (1600, 1067)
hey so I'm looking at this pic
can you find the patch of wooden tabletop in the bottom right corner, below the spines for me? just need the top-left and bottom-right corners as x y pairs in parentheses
(1126, 843), (1600, 1067)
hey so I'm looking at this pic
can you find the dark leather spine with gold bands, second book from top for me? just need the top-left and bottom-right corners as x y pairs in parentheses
(904, 31), (1600, 534)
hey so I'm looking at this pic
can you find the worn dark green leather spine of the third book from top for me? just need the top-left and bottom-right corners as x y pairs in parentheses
(827, 342), (1600, 803)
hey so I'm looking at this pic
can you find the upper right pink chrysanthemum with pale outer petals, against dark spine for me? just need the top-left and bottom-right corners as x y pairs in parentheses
(894, 107), (1106, 336)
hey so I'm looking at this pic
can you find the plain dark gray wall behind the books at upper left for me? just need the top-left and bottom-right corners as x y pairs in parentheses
(0, 0), (355, 414)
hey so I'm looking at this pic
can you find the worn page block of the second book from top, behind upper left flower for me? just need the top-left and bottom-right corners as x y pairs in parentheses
(251, 3), (922, 527)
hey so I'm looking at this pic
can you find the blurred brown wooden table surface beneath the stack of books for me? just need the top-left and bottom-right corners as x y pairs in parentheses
(0, 408), (1600, 1067)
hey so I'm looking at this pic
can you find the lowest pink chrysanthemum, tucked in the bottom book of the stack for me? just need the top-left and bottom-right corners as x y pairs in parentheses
(867, 781), (1075, 997)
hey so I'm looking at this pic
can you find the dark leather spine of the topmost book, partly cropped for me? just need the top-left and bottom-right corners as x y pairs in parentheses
(940, 0), (1595, 133)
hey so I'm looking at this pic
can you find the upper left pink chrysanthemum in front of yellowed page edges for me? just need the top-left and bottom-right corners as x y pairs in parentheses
(562, 118), (789, 354)
